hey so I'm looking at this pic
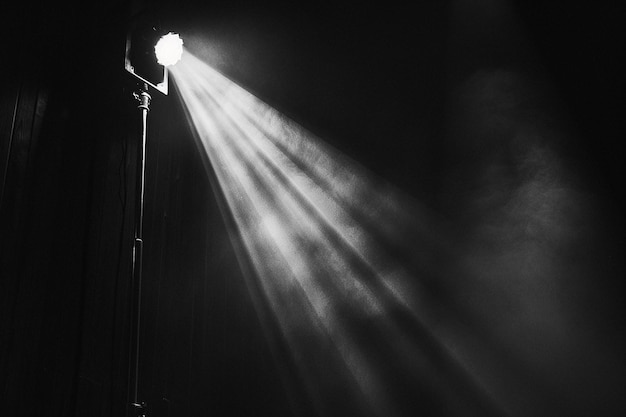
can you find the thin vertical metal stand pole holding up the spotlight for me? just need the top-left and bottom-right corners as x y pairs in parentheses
(128, 84), (151, 417)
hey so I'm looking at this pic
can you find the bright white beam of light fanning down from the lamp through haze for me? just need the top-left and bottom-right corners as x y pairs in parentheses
(171, 47), (502, 416)
